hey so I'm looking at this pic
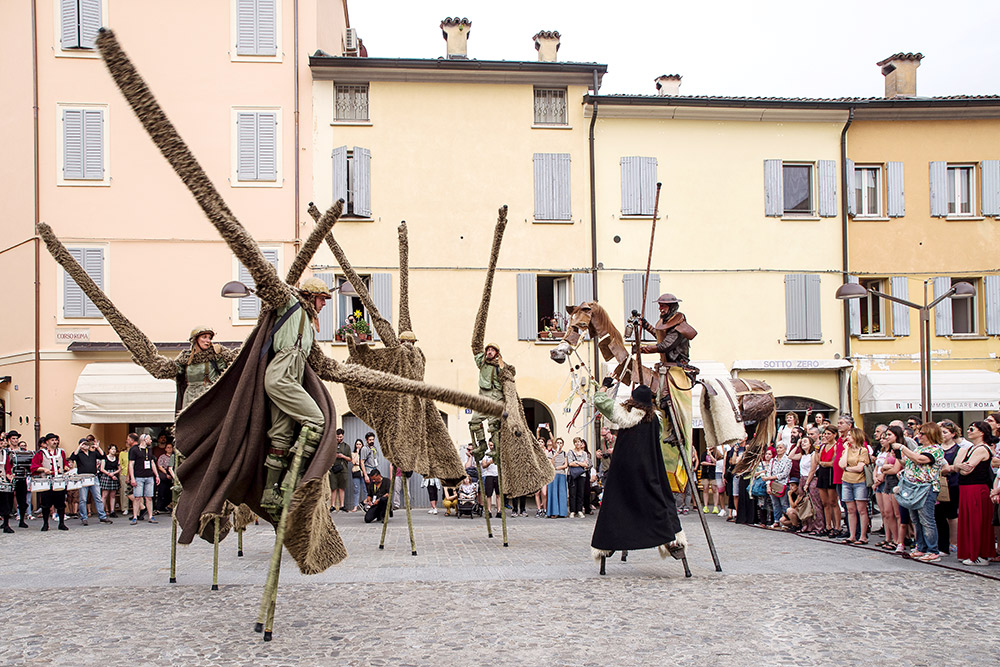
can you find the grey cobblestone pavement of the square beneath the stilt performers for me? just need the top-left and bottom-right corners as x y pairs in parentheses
(0, 511), (1000, 666)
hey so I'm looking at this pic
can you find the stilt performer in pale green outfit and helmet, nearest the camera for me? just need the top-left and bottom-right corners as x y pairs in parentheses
(260, 278), (331, 510)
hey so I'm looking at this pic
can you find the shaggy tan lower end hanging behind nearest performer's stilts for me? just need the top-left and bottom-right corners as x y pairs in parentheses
(285, 475), (347, 574)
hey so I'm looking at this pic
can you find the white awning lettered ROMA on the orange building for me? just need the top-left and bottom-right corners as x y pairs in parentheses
(858, 370), (1000, 413)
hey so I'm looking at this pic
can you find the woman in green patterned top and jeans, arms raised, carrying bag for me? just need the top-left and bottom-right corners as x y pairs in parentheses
(892, 422), (944, 563)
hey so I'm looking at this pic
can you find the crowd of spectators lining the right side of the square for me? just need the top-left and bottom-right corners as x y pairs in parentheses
(720, 412), (1000, 566)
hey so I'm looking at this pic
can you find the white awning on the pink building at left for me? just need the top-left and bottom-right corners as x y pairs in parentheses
(70, 362), (177, 425)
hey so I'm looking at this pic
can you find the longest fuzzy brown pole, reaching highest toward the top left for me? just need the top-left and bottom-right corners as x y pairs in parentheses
(97, 28), (293, 308)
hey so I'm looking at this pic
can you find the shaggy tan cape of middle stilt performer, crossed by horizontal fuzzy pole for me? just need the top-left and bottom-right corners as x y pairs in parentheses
(344, 339), (465, 482)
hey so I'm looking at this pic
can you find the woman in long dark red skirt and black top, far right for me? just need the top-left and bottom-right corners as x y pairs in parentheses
(955, 421), (997, 565)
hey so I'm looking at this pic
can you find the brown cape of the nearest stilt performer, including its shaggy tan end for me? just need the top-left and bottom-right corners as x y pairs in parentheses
(176, 311), (347, 574)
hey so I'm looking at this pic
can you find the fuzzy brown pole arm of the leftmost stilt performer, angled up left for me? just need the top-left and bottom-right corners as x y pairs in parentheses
(37, 222), (179, 379)
